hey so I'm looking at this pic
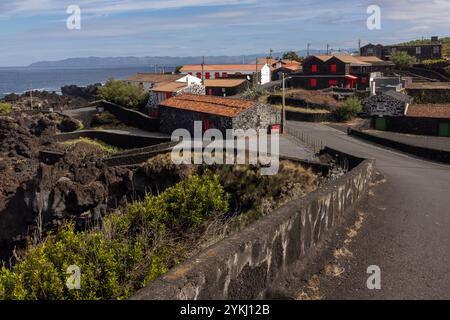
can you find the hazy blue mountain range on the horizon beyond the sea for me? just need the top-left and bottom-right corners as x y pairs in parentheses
(29, 49), (354, 68)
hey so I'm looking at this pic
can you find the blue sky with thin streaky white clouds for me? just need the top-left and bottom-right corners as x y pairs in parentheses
(0, 0), (450, 66)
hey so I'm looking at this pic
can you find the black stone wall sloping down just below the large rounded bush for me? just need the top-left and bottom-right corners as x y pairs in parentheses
(98, 101), (159, 132)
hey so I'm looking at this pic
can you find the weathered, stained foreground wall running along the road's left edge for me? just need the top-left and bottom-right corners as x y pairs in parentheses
(132, 155), (374, 300)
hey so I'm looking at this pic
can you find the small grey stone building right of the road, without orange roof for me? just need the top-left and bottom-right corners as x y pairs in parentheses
(361, 90), (413, 117)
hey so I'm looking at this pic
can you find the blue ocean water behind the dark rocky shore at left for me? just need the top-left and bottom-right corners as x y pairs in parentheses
(0, 67), (172, 98)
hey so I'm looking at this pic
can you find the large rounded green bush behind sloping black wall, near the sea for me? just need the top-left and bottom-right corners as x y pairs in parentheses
(98, 79), (150, 110)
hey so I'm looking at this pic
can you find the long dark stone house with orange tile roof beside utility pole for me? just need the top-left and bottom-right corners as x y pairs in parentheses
(158, 94), (281, 134)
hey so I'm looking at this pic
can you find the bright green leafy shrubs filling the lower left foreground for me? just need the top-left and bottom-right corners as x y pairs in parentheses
(0, 173), (229, 300)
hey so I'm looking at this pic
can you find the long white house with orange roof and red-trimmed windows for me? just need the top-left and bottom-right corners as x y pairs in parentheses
(180, 64), (272, 84)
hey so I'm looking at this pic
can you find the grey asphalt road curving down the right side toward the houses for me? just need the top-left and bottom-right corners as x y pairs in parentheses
(289, 122), (450, 299)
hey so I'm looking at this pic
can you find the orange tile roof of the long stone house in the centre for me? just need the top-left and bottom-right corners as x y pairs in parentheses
(160, 94), (255, 117)
